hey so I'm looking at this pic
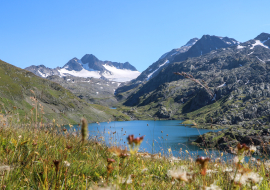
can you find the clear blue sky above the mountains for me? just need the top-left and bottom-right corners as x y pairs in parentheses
(0, 0), (270, 71)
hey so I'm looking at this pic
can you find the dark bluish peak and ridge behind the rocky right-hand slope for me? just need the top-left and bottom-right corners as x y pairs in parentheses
(116, 35), (239, 99)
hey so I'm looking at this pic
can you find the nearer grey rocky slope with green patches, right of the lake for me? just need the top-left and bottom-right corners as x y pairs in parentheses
(118, 32), (270, 125)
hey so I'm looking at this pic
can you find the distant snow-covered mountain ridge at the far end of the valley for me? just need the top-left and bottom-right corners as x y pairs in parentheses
(25, 54), (140, 82)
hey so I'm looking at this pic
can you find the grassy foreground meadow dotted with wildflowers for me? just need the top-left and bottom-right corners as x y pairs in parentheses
(0, 112), (270, 189)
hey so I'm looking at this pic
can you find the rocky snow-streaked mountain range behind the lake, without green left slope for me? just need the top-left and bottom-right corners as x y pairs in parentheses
(17, 33), (270, 125)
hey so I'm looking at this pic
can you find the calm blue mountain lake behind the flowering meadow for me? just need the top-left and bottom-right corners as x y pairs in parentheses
(70, 120), (230, 157)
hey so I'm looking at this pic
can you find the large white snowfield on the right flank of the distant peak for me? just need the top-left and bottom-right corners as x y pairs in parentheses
(103, 64), (141, 82)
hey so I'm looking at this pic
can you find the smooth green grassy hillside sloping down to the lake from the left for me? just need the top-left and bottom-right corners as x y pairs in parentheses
(0, 60), (128, 124)
